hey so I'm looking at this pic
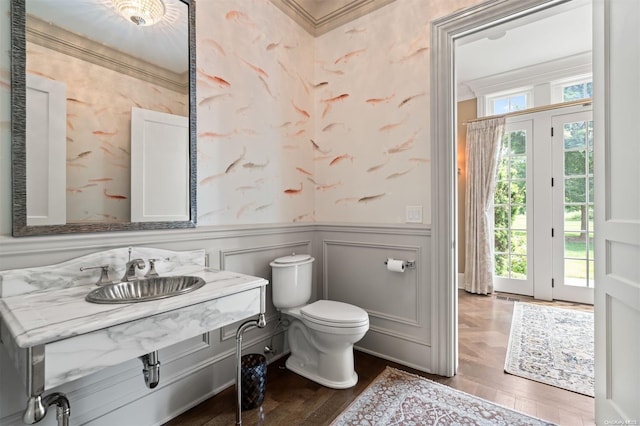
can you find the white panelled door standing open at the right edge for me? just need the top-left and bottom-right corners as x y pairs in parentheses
(593, 0), (640, 425)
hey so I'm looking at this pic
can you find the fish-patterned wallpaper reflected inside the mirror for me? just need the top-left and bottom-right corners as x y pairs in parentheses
(27, 42), (189, 223)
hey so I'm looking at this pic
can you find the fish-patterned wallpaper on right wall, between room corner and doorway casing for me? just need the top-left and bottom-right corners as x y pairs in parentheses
(314, 0), (430, 223)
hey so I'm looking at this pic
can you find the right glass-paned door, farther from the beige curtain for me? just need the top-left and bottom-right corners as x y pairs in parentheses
(552, 111), (595, 303)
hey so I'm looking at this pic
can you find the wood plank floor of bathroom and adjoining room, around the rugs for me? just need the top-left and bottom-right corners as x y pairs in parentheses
(166, 291), (595, 426)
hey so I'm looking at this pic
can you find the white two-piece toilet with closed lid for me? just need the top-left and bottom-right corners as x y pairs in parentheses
(270, 254), (369, 389)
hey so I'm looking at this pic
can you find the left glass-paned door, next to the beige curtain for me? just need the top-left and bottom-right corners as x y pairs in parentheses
(493, 120), (533, 295)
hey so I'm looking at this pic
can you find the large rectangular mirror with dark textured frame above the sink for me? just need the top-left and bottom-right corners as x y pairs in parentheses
(11, 0), (197, 236)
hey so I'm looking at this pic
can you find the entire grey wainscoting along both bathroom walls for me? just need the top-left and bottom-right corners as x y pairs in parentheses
(0, 224), (432, 426)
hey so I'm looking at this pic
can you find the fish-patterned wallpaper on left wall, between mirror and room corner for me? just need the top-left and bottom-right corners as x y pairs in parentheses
(196, 0), (316, 225)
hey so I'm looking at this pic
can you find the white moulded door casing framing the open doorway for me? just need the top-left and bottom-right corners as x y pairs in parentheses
(430, 0), (588, 376)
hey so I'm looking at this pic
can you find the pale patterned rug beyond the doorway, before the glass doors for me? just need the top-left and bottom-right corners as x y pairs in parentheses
(504, 302), (594, 396)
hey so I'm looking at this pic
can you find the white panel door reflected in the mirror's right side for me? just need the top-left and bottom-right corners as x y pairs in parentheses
(131, 108), (191, 222)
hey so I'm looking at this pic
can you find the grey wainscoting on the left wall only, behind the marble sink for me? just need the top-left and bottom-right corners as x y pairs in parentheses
(0, 224), (317, 426)
